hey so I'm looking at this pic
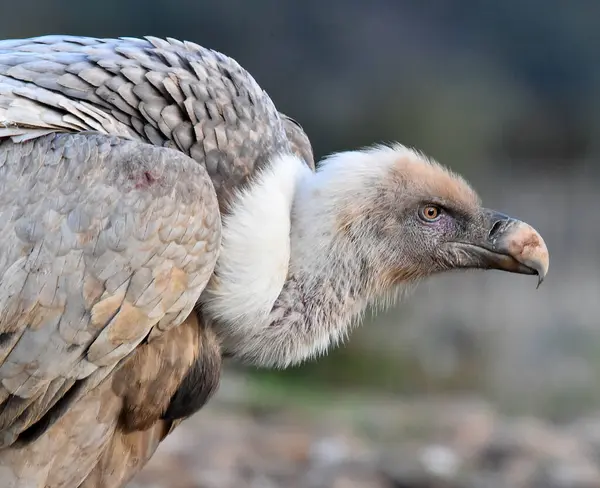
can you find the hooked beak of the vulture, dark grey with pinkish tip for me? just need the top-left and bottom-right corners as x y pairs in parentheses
(452, 209), (550, 288)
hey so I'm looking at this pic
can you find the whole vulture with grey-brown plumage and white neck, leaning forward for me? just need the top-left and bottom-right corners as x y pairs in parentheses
(0, 36), (548, 488)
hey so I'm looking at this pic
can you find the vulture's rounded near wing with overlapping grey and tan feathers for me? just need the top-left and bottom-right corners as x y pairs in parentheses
(0, 134), (220, 446)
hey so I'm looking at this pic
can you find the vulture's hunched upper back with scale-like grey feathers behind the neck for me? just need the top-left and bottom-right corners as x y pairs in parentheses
(0, 36), (314, 205)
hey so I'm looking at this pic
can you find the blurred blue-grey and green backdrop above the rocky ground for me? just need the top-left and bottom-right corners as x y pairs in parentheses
(0, 0), (600, 418)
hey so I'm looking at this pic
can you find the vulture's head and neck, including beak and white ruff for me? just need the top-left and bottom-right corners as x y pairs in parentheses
(200, 144), (549, 367)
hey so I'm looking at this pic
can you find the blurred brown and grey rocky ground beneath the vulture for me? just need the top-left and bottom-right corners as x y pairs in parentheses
(129, 373), (600, 488)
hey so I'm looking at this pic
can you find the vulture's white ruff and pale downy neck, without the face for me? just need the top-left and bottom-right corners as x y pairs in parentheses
(200, 145), (452, 367)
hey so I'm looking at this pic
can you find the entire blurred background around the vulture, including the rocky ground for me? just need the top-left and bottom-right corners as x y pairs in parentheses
(0, 0), (600, 488)
